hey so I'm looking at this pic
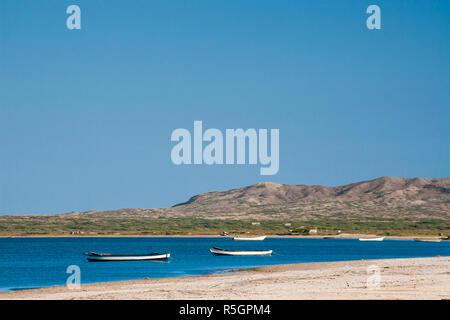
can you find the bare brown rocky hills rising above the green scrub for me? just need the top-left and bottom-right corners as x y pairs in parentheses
(75, 177), (450, 220)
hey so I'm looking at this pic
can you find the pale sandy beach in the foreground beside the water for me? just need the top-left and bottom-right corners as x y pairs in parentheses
(0, 257), (450, 300)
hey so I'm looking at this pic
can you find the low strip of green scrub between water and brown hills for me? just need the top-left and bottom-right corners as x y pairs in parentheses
(0, 215), (450, 236)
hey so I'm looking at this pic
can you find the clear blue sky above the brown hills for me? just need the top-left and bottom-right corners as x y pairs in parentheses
(0, 0), (450, 214)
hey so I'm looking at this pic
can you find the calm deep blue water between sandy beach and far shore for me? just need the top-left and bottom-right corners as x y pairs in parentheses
(0, 237), (450, 291)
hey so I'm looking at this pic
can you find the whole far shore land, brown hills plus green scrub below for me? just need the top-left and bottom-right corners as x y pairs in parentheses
(0, 177), (450, 235)
